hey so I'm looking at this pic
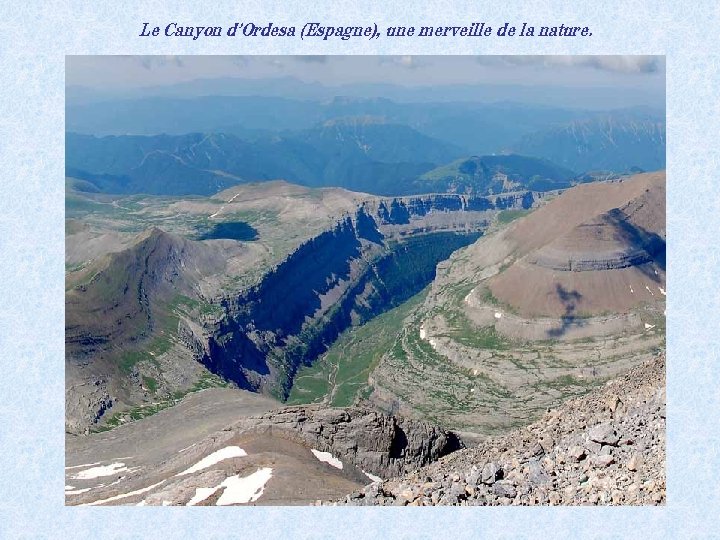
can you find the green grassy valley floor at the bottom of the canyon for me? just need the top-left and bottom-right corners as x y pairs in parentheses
(287, 289), (427, 407)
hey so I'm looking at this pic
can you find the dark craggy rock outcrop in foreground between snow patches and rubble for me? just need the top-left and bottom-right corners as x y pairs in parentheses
(231, 405), (463, 478)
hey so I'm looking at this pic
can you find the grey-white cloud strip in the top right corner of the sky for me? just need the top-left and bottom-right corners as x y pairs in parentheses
(477, 55), (665, 73)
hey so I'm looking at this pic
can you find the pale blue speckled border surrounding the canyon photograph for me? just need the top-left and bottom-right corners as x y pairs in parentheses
(0, 0), (720, 540)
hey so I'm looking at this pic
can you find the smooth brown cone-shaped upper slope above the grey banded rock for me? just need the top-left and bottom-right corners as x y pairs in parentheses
(471, 174), (665, 317)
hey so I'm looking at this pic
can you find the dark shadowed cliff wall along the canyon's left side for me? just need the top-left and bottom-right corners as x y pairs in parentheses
(183, 192), (534, 398)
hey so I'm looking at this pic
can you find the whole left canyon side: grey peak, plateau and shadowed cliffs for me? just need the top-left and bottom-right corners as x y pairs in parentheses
(66, 182), (535, 432)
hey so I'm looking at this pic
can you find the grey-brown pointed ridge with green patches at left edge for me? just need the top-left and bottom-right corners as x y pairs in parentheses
(65, 229), (242, 432)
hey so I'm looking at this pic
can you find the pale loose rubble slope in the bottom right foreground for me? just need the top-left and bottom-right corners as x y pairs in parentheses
(330, 355), (666, 506)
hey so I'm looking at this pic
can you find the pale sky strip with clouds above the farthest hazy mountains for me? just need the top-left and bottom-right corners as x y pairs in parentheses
(66, 56), (665, 89)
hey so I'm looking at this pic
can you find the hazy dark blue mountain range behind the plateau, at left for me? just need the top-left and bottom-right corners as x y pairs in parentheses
(66, 120), (463, 195)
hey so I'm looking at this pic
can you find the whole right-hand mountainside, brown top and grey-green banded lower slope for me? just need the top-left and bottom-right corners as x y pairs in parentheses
(369, 173), (665, 435)
